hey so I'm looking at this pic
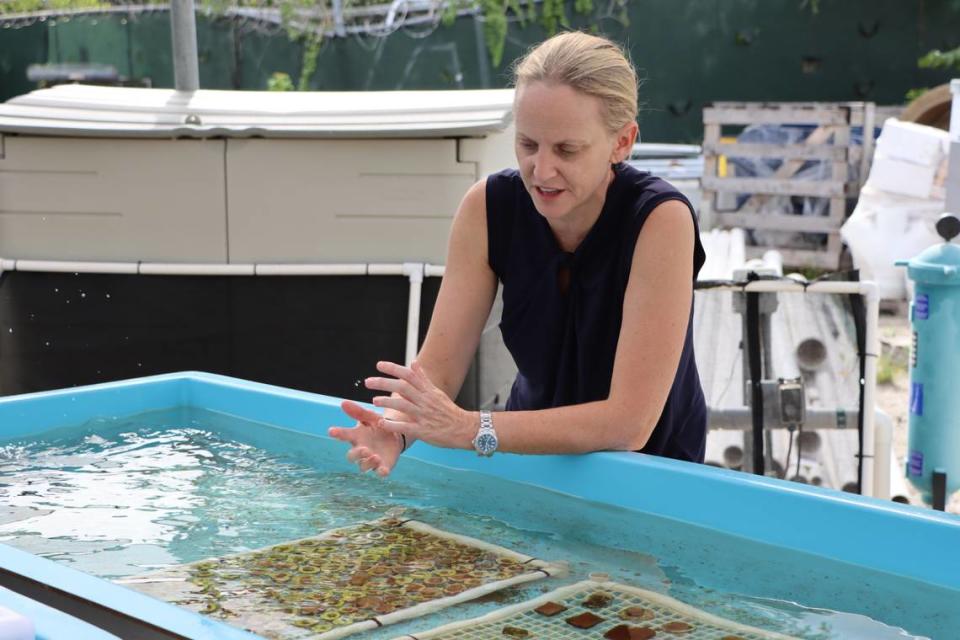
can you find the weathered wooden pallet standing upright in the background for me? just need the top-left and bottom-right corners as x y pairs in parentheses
(701, 102), (875, 269)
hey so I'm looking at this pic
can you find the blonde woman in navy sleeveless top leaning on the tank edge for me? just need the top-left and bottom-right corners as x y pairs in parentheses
(330, 33), (706, 476)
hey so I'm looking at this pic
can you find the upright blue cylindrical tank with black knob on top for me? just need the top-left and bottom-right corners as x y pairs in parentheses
(897, 214), (960, 508)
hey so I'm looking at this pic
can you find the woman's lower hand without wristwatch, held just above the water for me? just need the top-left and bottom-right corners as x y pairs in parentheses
(327, 400), (404, 477)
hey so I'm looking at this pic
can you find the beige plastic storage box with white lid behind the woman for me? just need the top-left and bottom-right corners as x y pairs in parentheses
(0, 85), (516, 264)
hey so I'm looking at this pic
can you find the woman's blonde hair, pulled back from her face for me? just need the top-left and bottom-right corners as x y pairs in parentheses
(513, 31), (637, 132)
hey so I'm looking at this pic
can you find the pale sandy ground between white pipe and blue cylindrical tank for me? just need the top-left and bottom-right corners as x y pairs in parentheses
(877, 304), (960, 514)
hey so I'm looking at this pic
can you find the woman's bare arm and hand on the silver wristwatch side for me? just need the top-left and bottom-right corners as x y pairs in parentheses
(367, 201), (695, 453)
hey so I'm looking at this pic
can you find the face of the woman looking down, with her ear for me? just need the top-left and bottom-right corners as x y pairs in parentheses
(514, 82), (636, 223)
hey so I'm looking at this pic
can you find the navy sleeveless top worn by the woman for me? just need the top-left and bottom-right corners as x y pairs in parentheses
(486, 164), (707, 462)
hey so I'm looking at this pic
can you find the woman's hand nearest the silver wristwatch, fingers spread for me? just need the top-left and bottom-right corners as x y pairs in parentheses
(365, 361), (477, 449)
